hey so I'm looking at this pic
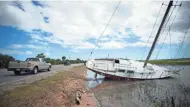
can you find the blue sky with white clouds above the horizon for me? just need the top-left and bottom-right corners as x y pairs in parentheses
(0, 0), (190, 60)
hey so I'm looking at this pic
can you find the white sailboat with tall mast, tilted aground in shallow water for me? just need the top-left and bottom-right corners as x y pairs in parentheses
(86, 1), (173, 80)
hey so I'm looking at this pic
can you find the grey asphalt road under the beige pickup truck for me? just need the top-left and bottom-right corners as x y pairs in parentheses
(0, 64), (82, 87)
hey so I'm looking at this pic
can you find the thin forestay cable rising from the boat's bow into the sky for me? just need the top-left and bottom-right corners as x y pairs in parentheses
(90, 1), (121, 55)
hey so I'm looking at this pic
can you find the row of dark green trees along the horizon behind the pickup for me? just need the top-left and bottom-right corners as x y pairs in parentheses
(0, 53), (86, 68)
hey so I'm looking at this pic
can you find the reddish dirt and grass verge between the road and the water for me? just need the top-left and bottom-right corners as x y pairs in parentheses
(0, 66), (97, 107)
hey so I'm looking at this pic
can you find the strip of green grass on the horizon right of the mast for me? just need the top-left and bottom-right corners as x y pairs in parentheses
(144, 58), (190, 65)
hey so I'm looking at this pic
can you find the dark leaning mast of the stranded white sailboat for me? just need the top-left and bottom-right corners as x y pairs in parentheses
(143, 0), (173, 67)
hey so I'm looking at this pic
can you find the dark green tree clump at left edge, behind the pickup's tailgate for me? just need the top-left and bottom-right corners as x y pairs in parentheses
(0, 54), (15, 68)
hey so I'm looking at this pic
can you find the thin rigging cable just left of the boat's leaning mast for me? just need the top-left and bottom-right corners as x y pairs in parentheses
(140, 3), (163, 60)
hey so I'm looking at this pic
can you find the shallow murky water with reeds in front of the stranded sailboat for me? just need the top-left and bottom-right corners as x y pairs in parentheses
(87, 66), (190, 107)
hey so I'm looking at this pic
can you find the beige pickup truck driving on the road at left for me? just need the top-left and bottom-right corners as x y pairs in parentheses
(7, 58), (51, 75)
